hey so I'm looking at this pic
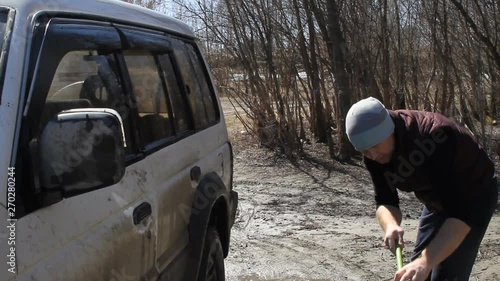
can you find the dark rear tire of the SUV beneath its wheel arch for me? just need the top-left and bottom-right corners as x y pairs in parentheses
(198, 226), (225, 281)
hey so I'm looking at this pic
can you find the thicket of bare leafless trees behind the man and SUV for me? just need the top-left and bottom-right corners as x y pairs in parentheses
(165, 0), (500, 160)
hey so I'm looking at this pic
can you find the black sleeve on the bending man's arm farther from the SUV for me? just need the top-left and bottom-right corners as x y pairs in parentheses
(425, 128), (477, 226)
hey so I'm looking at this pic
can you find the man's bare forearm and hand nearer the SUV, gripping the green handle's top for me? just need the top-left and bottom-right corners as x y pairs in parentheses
(375, 205), (404, 253)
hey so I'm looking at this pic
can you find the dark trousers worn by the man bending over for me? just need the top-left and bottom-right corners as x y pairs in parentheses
(411, 180), (498, 281)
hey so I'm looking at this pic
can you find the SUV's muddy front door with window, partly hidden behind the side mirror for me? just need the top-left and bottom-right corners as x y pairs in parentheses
(16, 19), (158, 281)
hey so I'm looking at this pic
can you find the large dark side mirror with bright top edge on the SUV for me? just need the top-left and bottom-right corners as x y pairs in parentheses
(39, 108), (125, 203)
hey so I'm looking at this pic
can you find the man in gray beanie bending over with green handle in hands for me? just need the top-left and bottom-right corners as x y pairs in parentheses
(346, 97), (498, 281)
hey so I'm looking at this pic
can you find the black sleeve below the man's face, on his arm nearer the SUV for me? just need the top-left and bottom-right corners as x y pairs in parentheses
(364, 157), (399, 208)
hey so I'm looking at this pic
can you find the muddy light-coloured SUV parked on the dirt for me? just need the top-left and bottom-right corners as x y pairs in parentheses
(0, 0), (238, 281)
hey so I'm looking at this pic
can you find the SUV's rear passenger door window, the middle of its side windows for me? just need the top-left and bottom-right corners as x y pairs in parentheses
(123, 50), (174, 146)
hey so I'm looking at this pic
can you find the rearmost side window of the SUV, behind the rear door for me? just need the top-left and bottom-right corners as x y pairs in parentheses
(173, 39), (217, 128)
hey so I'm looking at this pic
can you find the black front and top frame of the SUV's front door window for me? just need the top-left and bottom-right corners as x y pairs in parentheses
(15, 17), (134, 214)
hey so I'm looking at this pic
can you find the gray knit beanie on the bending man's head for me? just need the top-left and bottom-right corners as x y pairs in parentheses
(345, 97), (394, 151)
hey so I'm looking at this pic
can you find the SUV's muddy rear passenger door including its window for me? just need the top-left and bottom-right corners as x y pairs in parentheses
(115, 27), (198, 280)
